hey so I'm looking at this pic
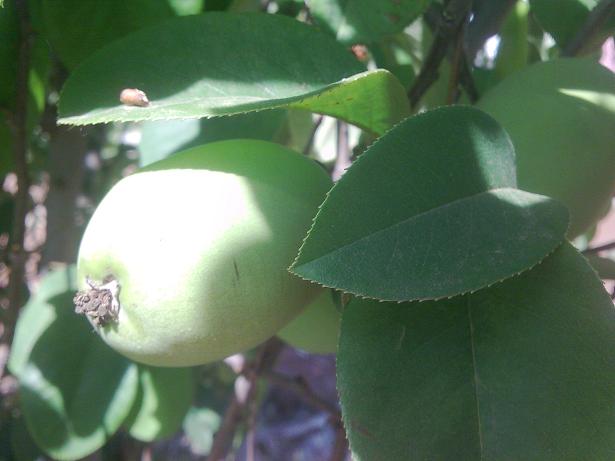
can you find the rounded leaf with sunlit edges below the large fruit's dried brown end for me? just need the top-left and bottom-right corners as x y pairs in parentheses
(10, 268), (138, 460)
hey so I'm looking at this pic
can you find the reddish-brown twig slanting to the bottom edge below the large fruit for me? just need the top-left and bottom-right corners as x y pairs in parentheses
(207, 339), (284, 461)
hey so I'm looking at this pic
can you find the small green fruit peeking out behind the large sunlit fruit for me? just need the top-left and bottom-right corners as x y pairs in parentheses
(278, 290), (342, 354)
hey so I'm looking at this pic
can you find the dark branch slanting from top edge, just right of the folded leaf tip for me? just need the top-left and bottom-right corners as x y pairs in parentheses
(408, 0), (472, 108)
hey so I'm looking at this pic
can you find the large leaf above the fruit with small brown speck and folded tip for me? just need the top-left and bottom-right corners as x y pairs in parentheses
(59, 13), (409, 133)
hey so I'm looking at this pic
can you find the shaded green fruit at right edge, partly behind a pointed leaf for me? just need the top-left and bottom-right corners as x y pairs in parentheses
(477, 58), (615, 237)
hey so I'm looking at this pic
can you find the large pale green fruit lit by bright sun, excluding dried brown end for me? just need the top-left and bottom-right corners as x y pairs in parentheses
(78, 140), (331, 366)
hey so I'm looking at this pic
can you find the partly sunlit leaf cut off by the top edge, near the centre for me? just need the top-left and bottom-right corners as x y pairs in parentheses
(307, 0), (431, 45)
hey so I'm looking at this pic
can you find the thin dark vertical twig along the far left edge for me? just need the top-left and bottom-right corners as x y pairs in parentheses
(3, 0), (30, 344)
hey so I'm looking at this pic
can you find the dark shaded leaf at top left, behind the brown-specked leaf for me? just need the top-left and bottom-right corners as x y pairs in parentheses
(40, 0), (173, 69)
